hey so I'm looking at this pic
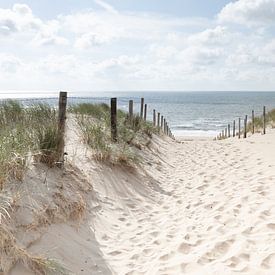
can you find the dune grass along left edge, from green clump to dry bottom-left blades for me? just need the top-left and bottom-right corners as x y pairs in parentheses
(0, 101), (72, 274)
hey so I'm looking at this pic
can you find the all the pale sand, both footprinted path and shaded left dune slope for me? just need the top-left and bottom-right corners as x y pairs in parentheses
(7, 117), (275, 275)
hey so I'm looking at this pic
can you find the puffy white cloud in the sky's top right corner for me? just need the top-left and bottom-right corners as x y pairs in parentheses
(218, 0), (275, 25)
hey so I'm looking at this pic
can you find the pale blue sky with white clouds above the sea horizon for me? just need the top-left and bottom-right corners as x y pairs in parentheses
(0, 0), (275, 91)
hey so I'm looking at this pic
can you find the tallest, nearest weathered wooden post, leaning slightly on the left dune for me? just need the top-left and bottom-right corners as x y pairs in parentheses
(57, 92), (67, 168)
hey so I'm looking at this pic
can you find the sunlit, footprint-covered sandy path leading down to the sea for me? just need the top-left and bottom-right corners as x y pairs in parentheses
(64, 119), (275, 275)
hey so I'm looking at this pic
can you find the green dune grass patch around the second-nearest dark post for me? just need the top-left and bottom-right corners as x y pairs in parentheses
(70, 103), (157, 166)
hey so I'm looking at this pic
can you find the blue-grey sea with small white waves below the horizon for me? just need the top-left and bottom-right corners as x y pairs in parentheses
(0, 91), (275, 137)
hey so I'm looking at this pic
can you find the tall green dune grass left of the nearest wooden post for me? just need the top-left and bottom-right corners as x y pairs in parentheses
(0, 101), (57, 190)
